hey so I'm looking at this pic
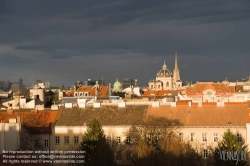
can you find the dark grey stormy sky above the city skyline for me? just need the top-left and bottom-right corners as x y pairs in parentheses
(0, 0), (250, 87)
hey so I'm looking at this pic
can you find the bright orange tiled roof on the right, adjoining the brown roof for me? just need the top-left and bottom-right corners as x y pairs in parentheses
(148, 102), (247, 126)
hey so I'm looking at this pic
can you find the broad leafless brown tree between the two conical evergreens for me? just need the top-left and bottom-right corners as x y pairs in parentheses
(128, 116), (208, 166)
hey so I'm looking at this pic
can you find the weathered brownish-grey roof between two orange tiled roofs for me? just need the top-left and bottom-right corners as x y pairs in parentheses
(55, 105), (148, 126)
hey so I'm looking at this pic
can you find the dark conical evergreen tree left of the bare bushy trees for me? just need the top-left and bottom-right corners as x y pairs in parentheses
(80, 119), (115, 166)
